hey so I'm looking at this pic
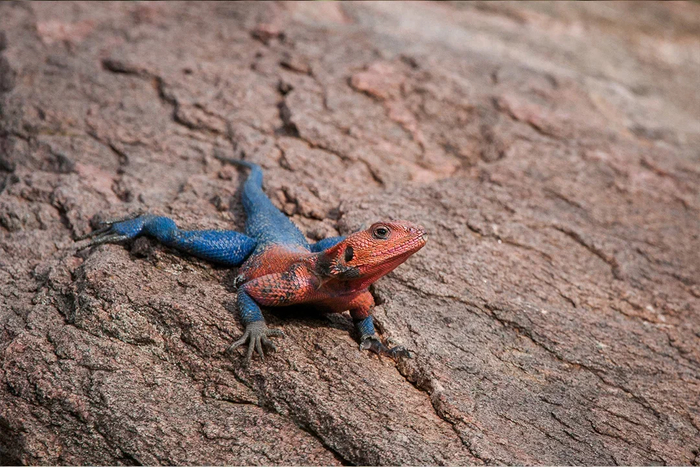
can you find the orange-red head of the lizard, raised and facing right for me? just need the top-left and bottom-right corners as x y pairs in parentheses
(317, 221), (427, 289)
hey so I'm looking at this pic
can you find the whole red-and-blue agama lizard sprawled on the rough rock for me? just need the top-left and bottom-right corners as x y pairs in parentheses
(77, 158), (426, 364)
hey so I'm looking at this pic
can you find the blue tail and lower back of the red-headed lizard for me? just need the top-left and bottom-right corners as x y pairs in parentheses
(217, 157), (309, 251)
